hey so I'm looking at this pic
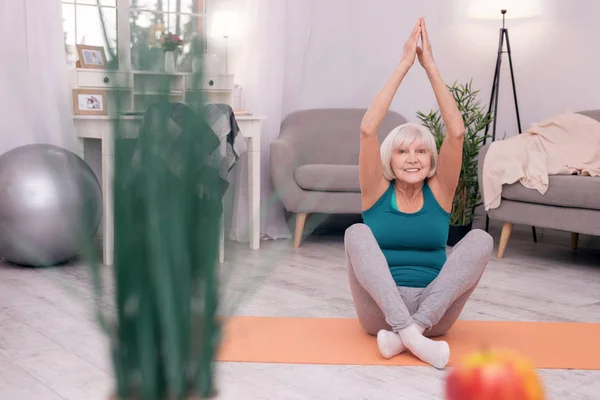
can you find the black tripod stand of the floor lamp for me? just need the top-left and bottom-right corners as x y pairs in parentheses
(483, 10), (537, 242)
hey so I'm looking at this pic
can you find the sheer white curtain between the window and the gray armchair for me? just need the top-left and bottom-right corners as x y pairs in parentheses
(223, 0), (310, 242)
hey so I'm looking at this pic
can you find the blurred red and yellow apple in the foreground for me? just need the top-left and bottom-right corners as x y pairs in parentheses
(446, 350), (544, 400)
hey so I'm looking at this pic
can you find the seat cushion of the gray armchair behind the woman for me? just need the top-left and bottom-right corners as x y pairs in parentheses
(294, 164), (360, 192)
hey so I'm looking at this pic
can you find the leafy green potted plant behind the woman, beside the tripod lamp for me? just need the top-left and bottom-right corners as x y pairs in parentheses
(417, 81), (492, 246)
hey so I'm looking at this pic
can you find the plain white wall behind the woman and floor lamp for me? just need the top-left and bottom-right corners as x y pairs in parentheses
(284, 0), (600, 137)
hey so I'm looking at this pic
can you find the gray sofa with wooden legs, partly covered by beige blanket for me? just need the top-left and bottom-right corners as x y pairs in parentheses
(478, 110), (600, 258)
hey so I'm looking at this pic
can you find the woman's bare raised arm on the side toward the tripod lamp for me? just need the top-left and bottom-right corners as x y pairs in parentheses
(417, 21), (465, 208)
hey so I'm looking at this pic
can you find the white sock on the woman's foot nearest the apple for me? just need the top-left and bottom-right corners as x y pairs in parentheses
(398, 324), (450, 369)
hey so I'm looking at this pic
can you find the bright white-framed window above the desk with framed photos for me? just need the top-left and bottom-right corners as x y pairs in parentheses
(61, 0), (206, 71)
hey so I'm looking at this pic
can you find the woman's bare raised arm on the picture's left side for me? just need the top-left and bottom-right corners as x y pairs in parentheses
(358, 19), (421, 210)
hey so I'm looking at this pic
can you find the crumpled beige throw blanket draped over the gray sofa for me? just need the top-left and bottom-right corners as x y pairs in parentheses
(482, 112), (600, 210)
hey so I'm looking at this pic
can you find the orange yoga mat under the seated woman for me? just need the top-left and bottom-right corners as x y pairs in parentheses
(217, 316), (600, 370)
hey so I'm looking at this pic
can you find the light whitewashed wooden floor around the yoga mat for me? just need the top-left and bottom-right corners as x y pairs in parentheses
(0, 225), (600, 400)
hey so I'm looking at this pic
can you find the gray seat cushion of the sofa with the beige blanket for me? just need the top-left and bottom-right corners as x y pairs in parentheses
(502, 175), (600, 210)
